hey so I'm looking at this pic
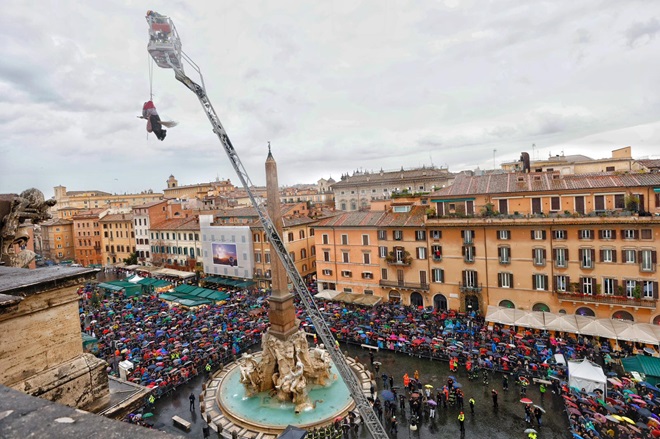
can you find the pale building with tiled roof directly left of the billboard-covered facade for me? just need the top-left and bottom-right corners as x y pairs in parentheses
(149, 215), (202, 271)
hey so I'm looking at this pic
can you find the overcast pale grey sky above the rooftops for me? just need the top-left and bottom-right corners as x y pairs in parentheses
(0, 0), (660, 196)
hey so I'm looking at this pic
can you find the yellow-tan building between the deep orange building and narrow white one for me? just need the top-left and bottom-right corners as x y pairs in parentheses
(99, 213), (135, 266)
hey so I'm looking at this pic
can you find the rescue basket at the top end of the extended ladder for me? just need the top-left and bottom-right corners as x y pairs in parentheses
(146, 11), (182, 69)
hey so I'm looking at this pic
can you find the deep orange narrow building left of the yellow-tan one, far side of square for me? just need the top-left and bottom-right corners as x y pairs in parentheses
(73, 209), (104, 267)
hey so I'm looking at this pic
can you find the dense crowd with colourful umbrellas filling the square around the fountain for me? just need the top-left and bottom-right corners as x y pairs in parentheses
(79, 285), (660, 439)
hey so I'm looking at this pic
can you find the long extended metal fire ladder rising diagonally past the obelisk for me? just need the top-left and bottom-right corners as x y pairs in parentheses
(153, 35), (388, 439)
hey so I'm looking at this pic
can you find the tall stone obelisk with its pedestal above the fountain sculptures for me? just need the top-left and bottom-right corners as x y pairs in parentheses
(266, 142), (298, 340)
